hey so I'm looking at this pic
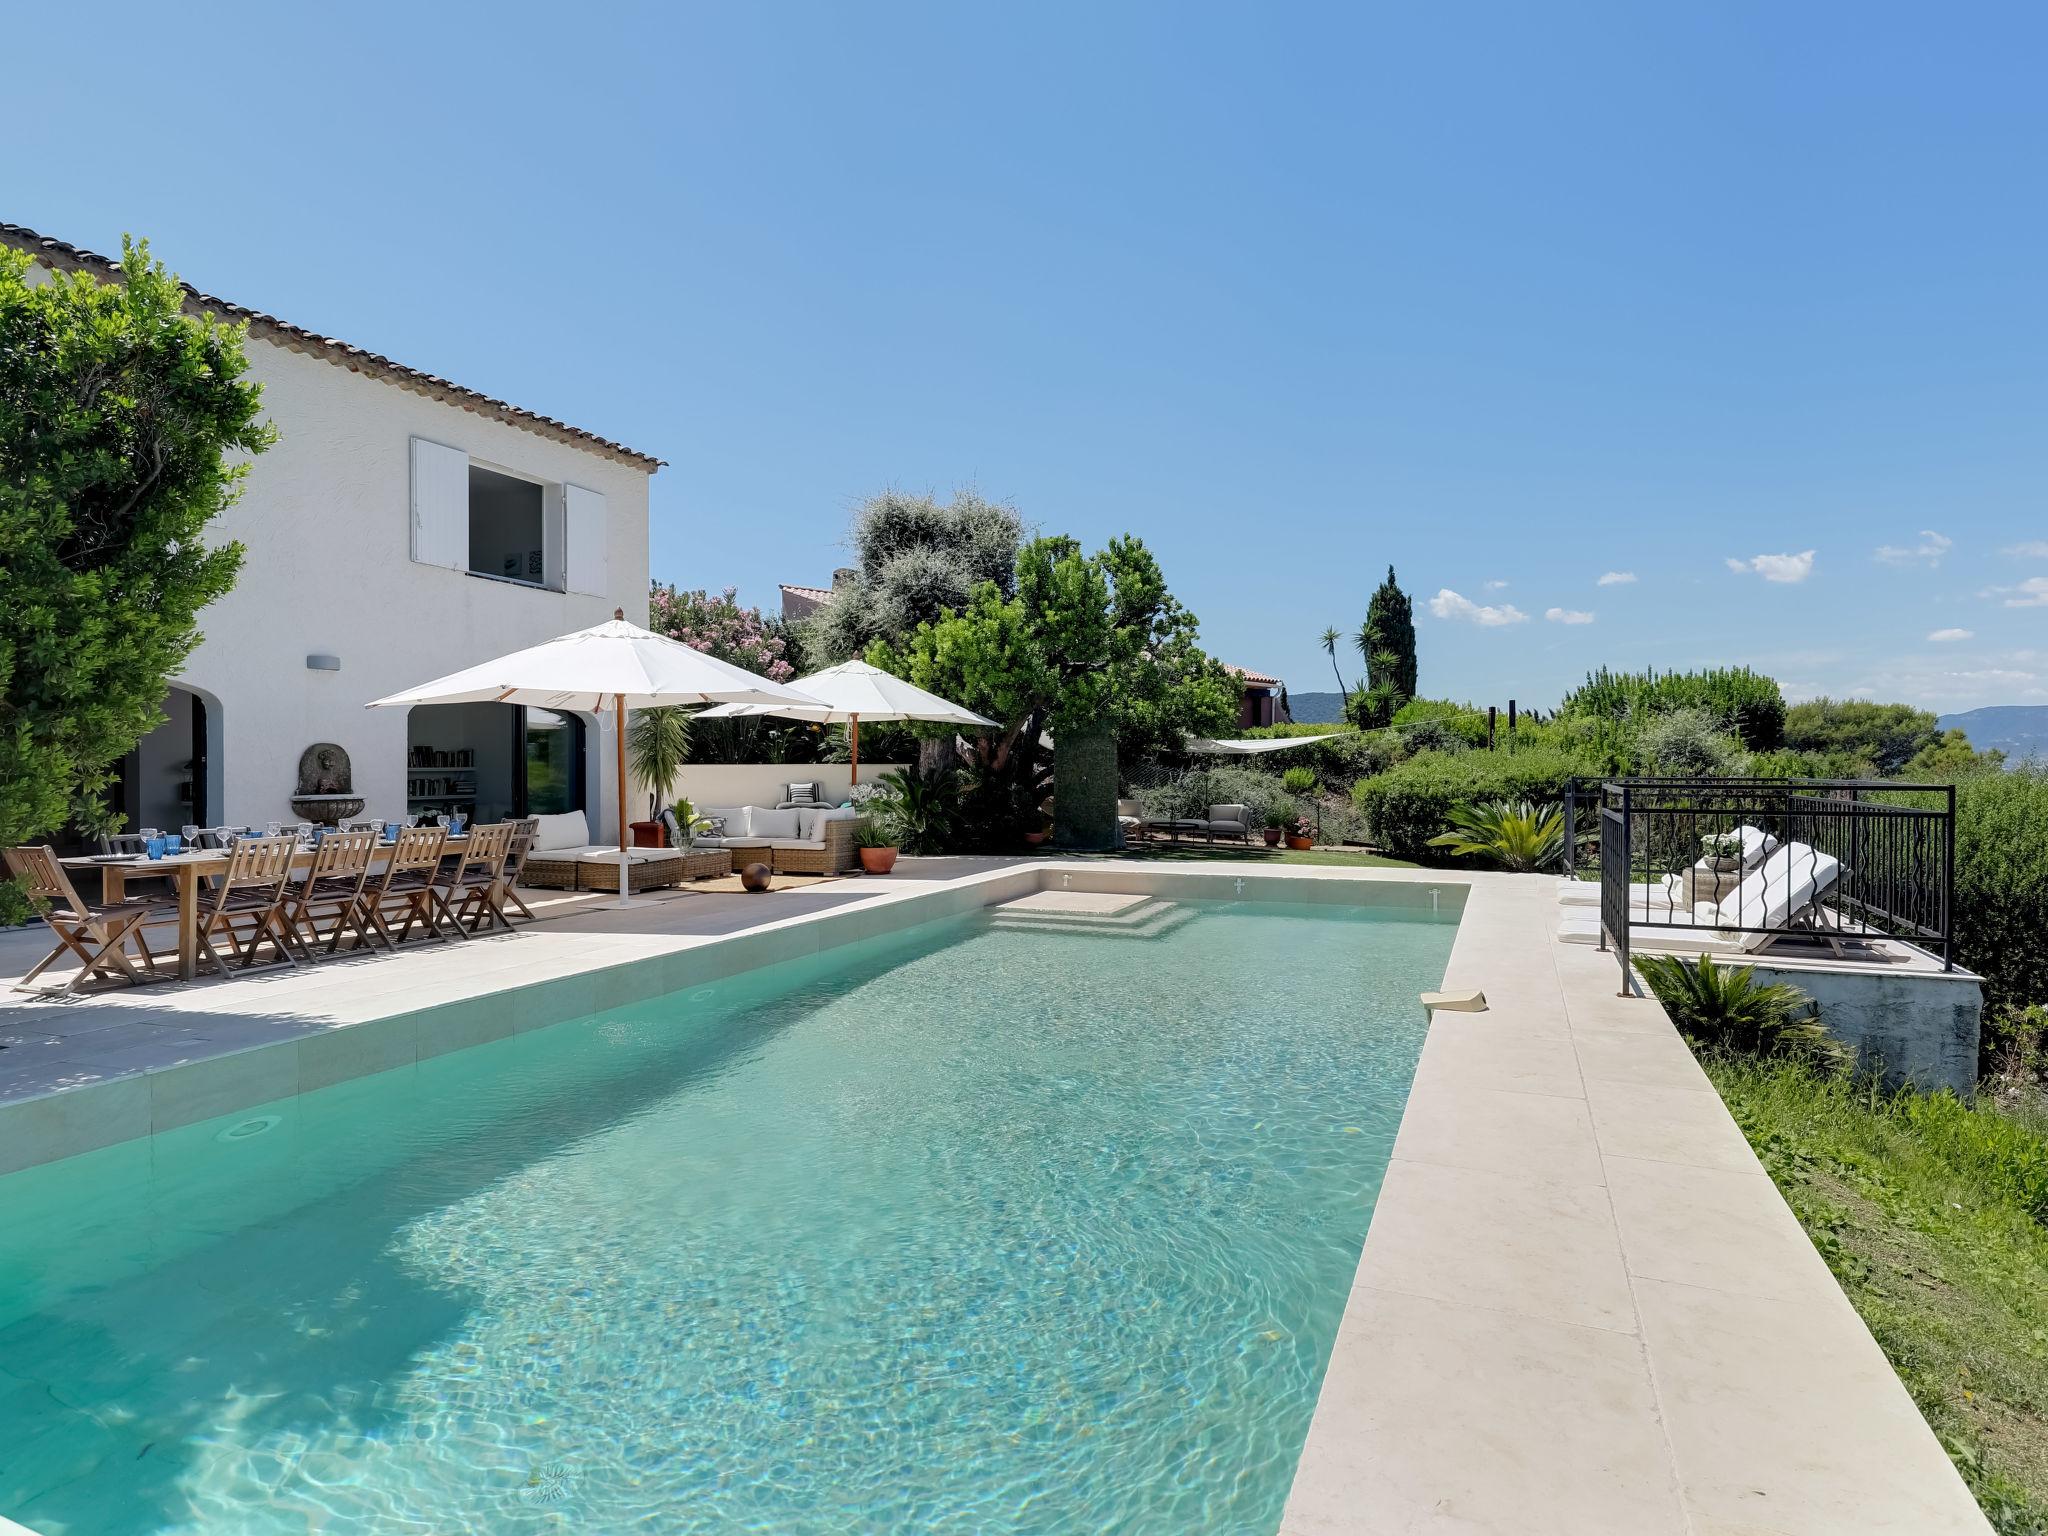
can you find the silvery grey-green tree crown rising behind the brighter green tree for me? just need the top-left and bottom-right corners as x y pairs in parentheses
(803, 489), (1024, 666)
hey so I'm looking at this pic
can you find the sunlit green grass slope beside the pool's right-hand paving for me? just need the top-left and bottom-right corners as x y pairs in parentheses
(1702, 1053), (2048, 1536)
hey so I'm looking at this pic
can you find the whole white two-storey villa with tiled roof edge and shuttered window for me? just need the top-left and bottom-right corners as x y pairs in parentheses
(0, 223), (662, 843)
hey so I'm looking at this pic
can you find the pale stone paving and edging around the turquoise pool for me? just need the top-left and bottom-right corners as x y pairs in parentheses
(0, 860), (1989, 1536)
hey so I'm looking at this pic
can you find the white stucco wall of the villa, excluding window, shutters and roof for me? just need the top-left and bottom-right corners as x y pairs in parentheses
(178, 340), (647, 827)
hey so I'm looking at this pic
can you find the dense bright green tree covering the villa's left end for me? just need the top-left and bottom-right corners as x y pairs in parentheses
(0, 242), (276, 844)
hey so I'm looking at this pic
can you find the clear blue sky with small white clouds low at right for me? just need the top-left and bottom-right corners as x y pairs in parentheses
(0, 0), (2048, 709)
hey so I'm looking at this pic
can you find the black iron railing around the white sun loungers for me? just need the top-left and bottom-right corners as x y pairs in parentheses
(1565, 778), (1956, 989)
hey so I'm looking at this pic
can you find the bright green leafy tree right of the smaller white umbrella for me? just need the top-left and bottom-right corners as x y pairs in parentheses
(868, 539), (1239, 856)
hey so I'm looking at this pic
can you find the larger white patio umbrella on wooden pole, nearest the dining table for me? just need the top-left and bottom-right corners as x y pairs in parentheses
(369, 608), (823, 903)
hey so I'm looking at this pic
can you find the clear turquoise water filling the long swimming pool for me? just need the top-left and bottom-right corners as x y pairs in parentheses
(0, 903), (1454, 1536)
